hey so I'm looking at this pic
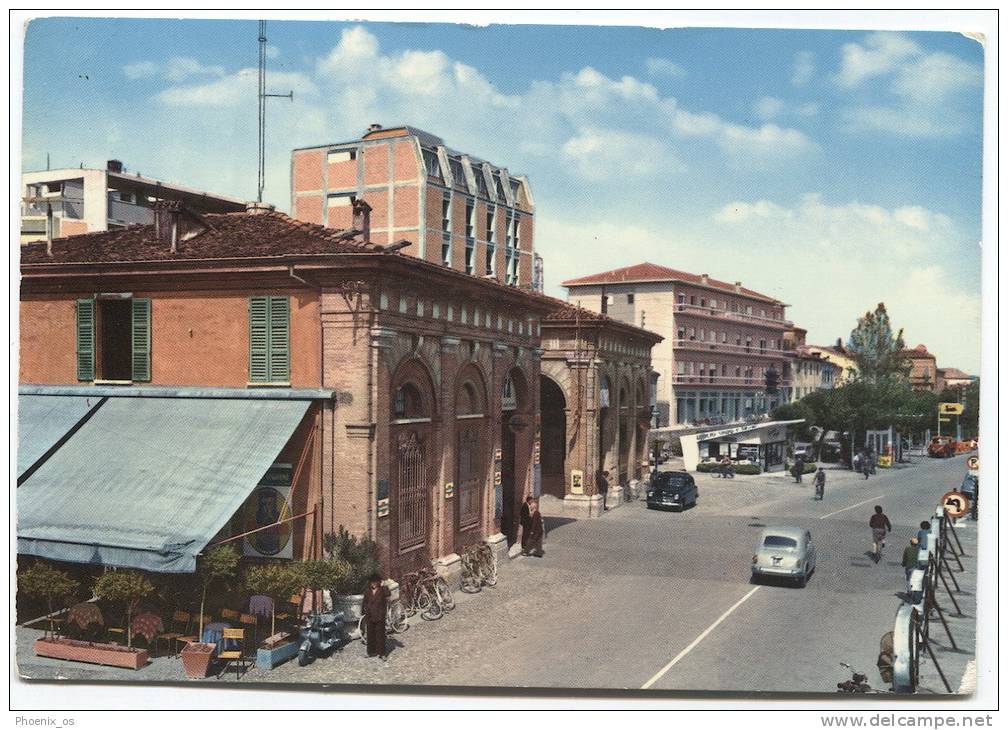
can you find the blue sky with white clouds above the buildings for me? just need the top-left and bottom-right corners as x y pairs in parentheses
(23, 18), (984, 372)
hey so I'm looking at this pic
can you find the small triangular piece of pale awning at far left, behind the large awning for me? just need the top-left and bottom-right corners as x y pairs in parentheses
(17, 395), (105, 479)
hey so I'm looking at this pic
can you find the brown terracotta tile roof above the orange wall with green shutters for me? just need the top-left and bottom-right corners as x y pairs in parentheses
(21, 211), (381, 264)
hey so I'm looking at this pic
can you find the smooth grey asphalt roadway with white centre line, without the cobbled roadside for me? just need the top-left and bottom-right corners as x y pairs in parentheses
(434, 458), (965, 694)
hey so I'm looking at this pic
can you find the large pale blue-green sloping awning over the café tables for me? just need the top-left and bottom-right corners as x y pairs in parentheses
(17, 395), (310, 573)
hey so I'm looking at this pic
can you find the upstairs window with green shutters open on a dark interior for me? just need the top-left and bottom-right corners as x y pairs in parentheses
(77, 297), (150, 381)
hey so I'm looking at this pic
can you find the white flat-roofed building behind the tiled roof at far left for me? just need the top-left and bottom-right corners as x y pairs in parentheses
(21, 159), (245, 243)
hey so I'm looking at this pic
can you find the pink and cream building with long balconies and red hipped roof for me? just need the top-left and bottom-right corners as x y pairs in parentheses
(563, 263), (793, 425)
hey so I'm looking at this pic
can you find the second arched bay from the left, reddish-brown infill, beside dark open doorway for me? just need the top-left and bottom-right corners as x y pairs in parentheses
(455, 366), (488, 555)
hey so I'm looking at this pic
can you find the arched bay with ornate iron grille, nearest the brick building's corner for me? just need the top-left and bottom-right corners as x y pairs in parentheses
(389, 360), (435, 575)
